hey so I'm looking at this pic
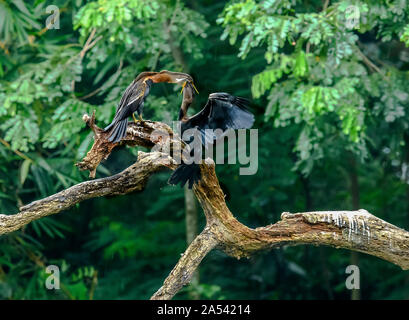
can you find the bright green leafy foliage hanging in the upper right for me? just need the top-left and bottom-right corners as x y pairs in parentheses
(218, 0), (407, 174)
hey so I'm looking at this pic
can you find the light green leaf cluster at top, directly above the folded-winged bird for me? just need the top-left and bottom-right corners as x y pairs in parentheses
(74, 0), (208, 68)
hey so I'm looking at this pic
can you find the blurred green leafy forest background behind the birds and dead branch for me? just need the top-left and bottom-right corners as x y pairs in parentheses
(0, 0), (409, 299)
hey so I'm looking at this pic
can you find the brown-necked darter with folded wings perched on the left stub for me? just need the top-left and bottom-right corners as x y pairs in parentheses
(104, 70), (197, 142)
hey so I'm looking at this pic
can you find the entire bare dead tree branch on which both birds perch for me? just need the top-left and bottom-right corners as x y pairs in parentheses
(0, 112), (409, 299)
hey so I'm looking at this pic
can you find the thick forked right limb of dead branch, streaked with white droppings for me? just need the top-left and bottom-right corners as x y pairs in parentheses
(151, 160), (409, 300)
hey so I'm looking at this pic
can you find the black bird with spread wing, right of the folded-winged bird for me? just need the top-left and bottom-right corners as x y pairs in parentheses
(169, 88), (254, 189)
